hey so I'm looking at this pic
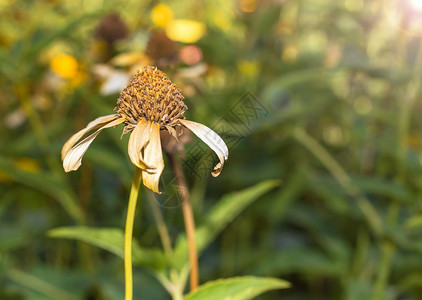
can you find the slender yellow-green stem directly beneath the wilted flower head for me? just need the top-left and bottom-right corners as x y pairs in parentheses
(124, 167), (142, 300)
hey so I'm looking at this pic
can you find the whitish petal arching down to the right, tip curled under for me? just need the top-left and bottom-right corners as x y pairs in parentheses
(179, 120), (229, 177)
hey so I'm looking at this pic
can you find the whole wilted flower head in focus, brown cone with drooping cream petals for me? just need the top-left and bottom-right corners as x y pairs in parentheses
(61, 66), (229, 193)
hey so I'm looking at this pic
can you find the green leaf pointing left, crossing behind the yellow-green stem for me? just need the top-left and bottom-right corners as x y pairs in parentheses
(48, 226), (167, 270)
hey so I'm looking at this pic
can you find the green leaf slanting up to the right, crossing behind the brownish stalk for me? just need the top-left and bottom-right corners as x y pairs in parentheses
(172, 180), (280, 268)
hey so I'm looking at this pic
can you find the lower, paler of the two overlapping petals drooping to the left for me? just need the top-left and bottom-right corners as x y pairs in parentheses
(63, 118), (125, 172)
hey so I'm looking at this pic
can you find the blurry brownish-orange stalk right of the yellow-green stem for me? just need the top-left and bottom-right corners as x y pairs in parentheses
(169, 154), (199, 291)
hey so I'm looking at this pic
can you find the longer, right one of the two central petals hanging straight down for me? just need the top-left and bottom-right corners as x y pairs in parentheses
(142, 121), (164, 193)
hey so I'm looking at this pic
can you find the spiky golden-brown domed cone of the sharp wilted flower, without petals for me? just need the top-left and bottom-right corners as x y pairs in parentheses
(114, 66), (187, 131)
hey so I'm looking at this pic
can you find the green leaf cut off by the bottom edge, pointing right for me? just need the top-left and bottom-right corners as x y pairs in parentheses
(184, 276), (290, 300)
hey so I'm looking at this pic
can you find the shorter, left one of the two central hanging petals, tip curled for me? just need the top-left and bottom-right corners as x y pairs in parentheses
(128, 119), (154, 172)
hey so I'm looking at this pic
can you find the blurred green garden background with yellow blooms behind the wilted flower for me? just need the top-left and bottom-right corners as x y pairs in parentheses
(0, 0), (422, 300)
